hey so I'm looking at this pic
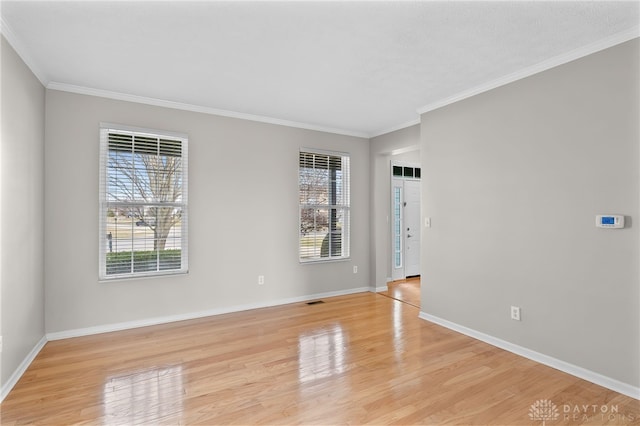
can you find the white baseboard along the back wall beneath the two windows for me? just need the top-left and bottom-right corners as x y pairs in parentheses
(47, 287), (371, 340)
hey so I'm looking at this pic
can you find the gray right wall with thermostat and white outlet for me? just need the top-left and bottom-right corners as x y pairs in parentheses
(421, 39), (640, 386)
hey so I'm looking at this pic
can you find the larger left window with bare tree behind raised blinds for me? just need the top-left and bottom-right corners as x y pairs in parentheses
(99, 125), (188, 279)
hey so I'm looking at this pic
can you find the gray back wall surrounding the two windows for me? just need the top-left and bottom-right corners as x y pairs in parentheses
(45, 90), (370, 332)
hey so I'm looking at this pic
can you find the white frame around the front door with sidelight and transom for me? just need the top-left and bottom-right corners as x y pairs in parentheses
(389, 160), (422, 281)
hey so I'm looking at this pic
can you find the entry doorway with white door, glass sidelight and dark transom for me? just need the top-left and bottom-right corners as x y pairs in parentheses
(390, 163), (422, 281)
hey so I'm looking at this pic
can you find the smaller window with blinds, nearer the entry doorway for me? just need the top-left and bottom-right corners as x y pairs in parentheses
(298, 151), (350, 262)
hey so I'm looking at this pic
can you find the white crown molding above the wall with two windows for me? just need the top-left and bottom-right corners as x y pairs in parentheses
(47, 81), (369, 139)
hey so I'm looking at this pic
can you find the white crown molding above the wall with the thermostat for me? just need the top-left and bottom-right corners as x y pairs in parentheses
(417, 25), (640, 114)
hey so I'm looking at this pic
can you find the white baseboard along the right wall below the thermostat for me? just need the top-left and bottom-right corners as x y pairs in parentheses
(418, 312), (640, 399)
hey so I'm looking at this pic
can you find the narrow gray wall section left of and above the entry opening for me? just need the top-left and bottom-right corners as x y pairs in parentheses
(370, 124), (420, 288)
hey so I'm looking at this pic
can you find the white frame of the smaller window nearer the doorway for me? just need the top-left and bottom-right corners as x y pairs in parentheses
(298, 147), (351, 264)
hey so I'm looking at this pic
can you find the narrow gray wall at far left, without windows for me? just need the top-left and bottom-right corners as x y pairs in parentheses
(0, 37), (45, 386)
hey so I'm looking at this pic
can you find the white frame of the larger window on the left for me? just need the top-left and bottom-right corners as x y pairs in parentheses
(98, 123), (189, 282)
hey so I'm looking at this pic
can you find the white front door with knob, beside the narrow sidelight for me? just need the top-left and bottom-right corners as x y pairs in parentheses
(403, 180), (420, 277)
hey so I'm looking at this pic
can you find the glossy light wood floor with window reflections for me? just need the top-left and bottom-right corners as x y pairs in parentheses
(1, 293), (640, 426)
